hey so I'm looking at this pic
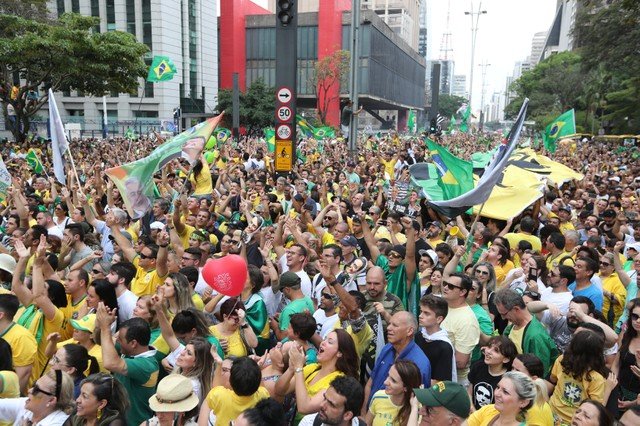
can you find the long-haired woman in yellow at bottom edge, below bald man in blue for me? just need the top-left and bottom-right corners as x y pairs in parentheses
(365, 359), (422, 426)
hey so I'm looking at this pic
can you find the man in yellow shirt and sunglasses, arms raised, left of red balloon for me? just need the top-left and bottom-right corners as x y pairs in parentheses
(105, 214), (169, 297)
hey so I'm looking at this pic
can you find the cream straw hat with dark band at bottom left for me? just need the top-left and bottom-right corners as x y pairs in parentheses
(149, 374), (199, 413)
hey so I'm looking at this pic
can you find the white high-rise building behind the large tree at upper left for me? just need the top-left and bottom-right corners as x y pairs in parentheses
(48, 0), (218, 135)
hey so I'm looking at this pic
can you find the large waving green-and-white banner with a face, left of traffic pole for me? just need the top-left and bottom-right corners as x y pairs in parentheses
(105, 114), (222, 219)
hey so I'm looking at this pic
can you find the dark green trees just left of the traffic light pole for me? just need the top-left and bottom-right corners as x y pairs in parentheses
(216, 78), (276, 136)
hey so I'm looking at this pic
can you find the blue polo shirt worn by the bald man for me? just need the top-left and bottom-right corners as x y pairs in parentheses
(367, 340), (431, 407)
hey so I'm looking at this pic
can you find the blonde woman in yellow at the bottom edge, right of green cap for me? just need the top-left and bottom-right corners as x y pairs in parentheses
(467, 371), (546, 426)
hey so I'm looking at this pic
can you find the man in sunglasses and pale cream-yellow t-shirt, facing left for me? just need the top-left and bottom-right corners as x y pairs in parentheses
(441, 273), (480, 385)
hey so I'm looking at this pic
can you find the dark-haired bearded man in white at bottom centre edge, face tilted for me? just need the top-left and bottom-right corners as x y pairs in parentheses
(299, 376), (366, 426)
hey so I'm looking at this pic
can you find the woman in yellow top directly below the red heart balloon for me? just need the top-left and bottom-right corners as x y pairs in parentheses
(210, 297), (258, 357)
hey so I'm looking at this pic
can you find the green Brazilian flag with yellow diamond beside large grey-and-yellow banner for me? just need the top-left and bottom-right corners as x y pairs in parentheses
(427, 139), (473, 200)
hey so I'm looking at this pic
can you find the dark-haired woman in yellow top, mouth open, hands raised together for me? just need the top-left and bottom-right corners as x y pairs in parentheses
(272, 329), (360, 421)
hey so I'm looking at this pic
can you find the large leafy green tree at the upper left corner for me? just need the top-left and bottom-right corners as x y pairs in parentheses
(0, 14), (148, 142)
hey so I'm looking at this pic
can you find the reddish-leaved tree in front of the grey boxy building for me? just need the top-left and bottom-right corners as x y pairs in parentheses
(309, 50), (351, 124)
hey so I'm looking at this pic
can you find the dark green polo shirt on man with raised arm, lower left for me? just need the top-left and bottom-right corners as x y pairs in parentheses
(114, 350), (159, 425)
